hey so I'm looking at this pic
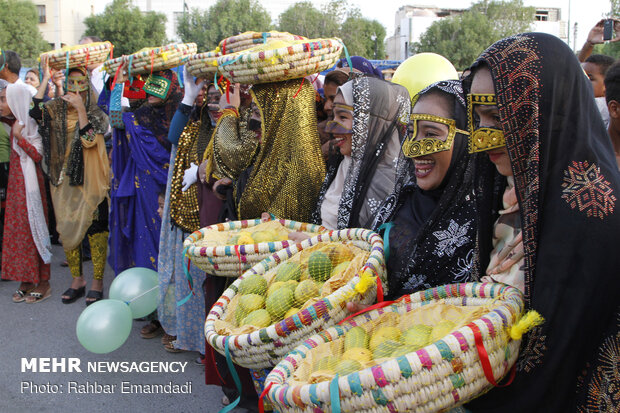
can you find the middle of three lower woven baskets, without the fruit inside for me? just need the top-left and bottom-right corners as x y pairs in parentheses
(205, 229), (385, 369)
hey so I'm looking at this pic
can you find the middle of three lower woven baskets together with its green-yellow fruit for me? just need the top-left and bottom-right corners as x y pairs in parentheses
(205, 229), (385, 369)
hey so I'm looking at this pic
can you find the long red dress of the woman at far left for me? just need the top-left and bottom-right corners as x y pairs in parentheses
(2, 133), (50, 284)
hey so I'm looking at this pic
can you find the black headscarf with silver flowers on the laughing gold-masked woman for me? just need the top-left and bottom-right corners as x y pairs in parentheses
(373, 80), (476, 298)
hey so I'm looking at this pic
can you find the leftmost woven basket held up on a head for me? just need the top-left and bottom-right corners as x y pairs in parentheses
(39, 42), (112, 70)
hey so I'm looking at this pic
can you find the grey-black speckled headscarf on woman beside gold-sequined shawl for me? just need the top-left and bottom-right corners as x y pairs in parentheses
(313, 76), (411, 229)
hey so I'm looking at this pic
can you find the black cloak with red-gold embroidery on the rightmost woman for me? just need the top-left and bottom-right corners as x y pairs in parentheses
(467, 33), (620, 412)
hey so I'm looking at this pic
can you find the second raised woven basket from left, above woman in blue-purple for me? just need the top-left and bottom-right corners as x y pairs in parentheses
(103, 43), (197, 76)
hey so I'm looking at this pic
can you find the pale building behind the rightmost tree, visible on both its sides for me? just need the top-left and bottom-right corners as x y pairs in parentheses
(386, 6), (568, 60)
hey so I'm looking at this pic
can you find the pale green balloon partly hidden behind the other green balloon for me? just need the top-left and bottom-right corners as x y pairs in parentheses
(108, 267), (159, 318)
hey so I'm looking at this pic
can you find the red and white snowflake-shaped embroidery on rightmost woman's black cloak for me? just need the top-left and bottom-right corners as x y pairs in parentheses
(562, 161), (616, 219)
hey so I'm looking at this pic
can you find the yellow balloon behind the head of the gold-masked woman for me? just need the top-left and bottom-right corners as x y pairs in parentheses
(392, 53), (459, 99)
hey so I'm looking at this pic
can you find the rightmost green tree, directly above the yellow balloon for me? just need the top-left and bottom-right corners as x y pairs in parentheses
(412, 0), (535, 70)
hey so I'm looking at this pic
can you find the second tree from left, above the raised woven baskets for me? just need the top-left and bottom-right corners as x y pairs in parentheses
(84, 0), (166, 56)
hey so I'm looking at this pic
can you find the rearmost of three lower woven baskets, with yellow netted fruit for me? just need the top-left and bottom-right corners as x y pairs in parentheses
(183, 219), (327, 278)
